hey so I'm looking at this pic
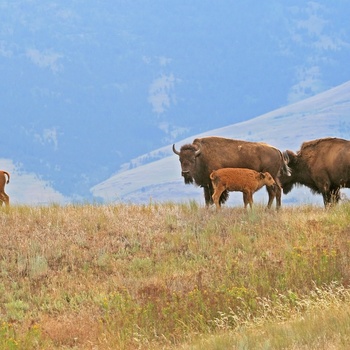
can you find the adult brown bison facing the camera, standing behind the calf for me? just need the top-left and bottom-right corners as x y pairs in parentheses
(173, 137), (289, 208)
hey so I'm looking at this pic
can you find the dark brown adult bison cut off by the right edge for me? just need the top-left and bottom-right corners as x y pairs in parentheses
(280, 137), (350, 208)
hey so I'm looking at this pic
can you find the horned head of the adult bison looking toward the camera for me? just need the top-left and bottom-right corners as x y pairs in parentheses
(173, 144), (201, 184)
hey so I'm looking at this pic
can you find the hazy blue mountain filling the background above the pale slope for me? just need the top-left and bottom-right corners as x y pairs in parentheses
(0, 0), (350, 200)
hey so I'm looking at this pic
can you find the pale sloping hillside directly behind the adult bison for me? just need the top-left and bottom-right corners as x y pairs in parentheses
(91, 81), (350, 204)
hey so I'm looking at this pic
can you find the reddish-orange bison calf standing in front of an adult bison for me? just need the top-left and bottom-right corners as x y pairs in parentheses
(210, 168), (277, 209)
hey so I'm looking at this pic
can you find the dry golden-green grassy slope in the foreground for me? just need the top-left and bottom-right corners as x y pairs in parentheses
(0, 202), (350, 350)
